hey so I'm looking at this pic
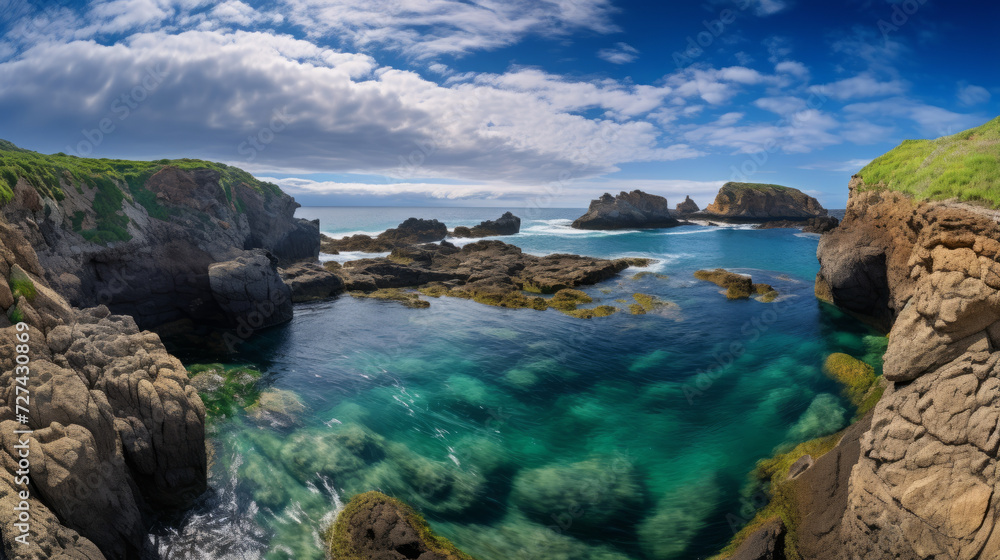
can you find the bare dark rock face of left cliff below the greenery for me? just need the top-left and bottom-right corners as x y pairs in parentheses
(0, 165), (319, 328)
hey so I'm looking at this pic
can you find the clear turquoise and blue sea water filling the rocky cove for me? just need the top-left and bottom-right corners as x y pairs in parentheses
(148, 208), (880, 560)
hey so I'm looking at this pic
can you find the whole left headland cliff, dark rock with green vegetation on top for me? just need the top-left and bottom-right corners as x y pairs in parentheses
(0, 143), (319, 328)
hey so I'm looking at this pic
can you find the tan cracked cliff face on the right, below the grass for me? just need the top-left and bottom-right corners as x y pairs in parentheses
(817, 177), (1000, 560)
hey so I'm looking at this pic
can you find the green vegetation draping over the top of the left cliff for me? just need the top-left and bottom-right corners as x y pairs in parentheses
(0, 140), (281, 243)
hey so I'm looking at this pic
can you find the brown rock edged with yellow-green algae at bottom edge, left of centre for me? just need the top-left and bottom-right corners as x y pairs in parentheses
(325, 492), (474, 560)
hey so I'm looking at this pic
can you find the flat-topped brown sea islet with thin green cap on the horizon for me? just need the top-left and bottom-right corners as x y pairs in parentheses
(703, 183), (827, 221)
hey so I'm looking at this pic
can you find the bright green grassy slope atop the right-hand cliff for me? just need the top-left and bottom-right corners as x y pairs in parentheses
(858, 117), (1000, 208)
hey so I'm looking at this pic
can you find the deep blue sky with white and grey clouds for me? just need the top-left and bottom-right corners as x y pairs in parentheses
(0, 0), (1000, 208)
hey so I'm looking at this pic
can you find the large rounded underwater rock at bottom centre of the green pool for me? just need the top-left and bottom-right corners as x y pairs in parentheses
(510, 458), (643, 533)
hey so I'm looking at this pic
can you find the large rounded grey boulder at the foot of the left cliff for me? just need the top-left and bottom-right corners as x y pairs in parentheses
(208, 250), (292, 329)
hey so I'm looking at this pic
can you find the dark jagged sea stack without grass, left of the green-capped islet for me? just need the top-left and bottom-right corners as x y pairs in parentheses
(573, 190), (680, 229)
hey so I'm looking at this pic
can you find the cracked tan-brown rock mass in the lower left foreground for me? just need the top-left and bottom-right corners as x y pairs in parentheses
(0, 221), (206, 560)
